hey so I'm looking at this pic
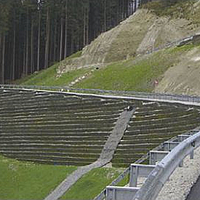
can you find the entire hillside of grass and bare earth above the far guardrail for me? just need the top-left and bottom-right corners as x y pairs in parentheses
(17, 1), (200, 94)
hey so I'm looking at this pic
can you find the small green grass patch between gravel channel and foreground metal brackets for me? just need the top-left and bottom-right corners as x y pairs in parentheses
(61, 168), (124, 200)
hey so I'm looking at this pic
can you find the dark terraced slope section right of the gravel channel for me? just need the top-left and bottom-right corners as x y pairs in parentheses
(112, 102), (200, 167)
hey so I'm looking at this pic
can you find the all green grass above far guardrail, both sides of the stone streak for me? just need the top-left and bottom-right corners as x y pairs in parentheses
(18, 45), (194, 92)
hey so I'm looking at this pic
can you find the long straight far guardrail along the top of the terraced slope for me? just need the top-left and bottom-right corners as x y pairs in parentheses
(0, 85), (200, 103)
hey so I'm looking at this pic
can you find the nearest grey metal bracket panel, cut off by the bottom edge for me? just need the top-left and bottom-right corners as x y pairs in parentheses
(106, 186), (139, 200)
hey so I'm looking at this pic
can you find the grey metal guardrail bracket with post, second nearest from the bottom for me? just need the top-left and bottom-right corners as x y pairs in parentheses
(129, 164), (156, 187)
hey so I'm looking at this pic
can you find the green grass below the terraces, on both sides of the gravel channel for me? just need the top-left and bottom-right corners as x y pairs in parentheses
(0, 156), (127, 200)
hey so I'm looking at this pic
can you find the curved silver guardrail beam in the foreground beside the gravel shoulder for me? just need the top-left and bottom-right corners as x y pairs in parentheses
(133, 131), (200, 200)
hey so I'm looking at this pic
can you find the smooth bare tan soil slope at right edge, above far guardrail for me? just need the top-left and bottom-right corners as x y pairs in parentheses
(155, 47), (200, 96)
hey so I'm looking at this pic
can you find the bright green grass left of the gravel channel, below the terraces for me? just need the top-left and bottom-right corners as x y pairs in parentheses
(0, 156), (76, 200)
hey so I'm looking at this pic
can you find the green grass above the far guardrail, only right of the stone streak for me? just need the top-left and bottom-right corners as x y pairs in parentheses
(75, 45), (193, 92)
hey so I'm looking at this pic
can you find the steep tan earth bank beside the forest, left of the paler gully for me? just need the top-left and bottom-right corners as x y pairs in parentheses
(57, 10), (156, 77)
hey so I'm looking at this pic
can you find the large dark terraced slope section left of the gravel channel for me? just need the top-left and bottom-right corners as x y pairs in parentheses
(0, 90), (130, 165)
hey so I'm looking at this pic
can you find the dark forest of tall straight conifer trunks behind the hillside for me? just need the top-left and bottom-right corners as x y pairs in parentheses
(0, 0), (153, 83)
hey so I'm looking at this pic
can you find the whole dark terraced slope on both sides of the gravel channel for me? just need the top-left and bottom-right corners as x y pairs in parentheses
(0, 89), (200, 167)
